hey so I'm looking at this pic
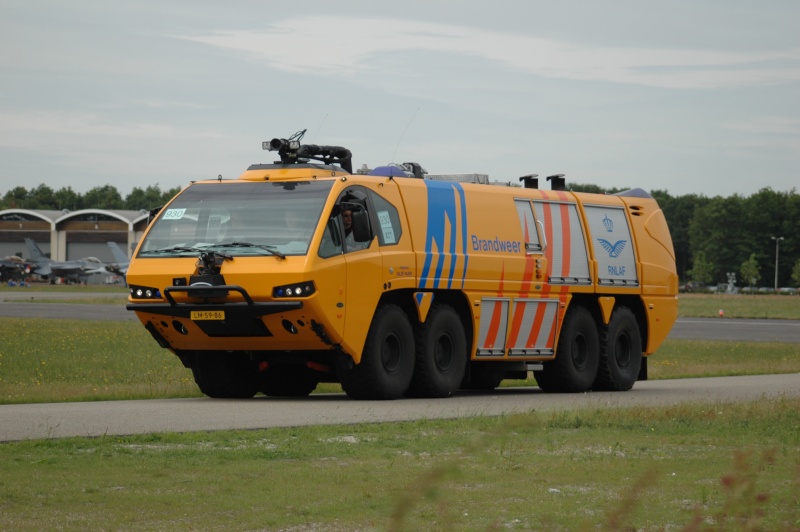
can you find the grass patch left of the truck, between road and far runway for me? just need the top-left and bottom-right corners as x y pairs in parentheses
(0, 318), (199, 403)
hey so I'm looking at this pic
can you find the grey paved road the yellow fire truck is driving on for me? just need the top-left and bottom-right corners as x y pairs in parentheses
(0, 373), (800, 441)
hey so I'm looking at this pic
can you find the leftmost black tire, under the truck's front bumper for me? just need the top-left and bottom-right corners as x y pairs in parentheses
(190, 351), (259, 399)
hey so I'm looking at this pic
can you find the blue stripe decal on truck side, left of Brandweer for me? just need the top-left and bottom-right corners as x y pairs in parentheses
(420, 181), (468, 288)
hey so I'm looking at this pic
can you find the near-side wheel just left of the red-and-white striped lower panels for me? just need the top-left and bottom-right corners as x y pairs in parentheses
(406, 305), (468, 397)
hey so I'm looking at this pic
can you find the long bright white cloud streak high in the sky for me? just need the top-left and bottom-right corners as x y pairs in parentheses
(176, 16), (800, 89)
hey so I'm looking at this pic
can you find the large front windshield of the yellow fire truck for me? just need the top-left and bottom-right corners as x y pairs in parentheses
(139, 181), (333, 257)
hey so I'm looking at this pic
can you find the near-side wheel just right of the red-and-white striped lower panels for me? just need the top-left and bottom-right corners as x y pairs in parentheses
(533, 306), (600, 393)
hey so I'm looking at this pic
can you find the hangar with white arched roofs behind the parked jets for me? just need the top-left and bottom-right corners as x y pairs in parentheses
(0, 209), (148, 263)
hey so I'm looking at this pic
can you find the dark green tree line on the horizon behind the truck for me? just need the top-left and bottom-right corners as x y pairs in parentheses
(0, 184), (800, 287)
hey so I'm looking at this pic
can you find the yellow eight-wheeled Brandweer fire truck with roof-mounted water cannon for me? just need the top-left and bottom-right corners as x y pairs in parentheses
(127, 132), (678, 399)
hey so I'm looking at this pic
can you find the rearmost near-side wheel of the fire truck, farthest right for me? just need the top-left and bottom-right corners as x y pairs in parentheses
(593, 307), (642, 391)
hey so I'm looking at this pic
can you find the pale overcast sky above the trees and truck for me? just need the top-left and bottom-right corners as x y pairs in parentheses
(0, 0), (800, 196)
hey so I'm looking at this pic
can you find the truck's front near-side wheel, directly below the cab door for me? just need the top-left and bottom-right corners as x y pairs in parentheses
(337, 305), (414, 399)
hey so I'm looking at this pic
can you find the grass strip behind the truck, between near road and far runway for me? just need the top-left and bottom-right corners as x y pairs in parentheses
(0, 318), (800, 404)
